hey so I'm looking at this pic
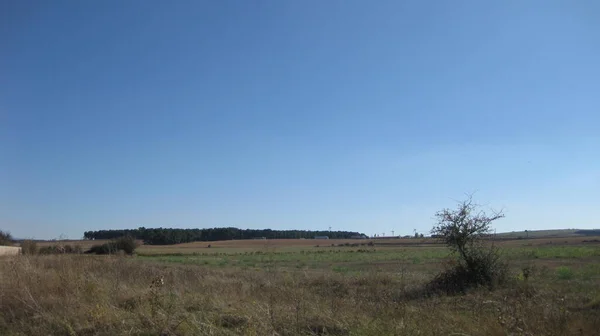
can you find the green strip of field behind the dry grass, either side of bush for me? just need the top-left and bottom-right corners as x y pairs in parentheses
(139, 246), (600, 275)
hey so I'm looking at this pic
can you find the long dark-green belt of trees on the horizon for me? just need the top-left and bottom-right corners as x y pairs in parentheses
(83, 227), (367, 245)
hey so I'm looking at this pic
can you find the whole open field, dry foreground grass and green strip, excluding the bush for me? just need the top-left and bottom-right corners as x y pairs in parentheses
(0, 238), (600, 335)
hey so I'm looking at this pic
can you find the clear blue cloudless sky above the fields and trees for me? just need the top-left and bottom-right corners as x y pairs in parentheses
(0, 0), (600, 238)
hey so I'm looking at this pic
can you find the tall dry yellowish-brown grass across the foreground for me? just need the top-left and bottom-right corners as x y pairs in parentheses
(0, 255), (600, 335)
